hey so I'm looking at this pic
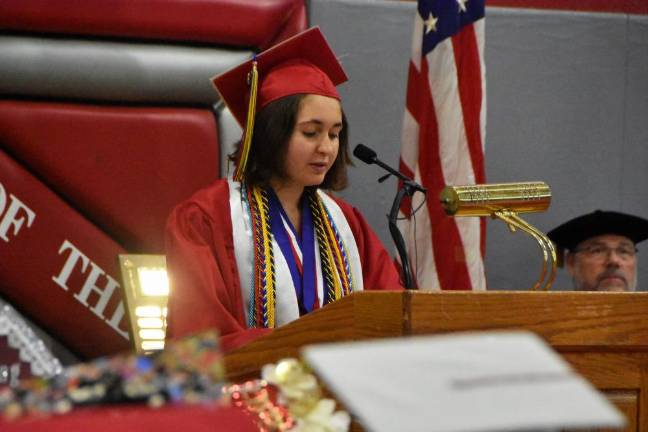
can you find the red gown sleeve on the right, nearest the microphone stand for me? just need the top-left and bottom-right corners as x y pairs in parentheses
(334, 197), (404, 290)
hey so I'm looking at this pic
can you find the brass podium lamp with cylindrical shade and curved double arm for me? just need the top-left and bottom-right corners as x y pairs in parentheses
(440, 182), (557, 290)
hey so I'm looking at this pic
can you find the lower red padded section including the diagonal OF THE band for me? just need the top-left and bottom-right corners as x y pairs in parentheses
(0, 100), (219, 358)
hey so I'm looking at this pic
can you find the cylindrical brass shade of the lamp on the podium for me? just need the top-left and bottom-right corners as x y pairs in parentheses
(439, 181), (551, 216)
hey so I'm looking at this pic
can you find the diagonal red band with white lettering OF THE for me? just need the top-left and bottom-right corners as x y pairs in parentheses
(0, 150), (129, 357)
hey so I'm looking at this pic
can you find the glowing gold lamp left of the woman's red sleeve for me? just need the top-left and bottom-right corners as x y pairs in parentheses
(119, 254), (169, 354)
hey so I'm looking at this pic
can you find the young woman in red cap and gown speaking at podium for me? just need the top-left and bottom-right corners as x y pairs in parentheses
(167, 28), (401, 350)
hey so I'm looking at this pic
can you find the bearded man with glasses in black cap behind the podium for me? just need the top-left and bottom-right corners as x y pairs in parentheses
(547, 210), (648, 291)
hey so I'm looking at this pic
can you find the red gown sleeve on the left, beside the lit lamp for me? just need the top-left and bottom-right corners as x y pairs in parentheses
(166, 181), (270, 351)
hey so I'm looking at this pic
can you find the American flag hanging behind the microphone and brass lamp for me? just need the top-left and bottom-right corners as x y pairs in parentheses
(399, 0), (486, 290)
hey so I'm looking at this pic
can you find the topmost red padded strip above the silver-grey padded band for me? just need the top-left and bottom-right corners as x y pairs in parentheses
(0, 0), (307, 49)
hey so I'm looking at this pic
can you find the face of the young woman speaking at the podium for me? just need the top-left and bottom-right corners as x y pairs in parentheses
(281, 95), (342, 187)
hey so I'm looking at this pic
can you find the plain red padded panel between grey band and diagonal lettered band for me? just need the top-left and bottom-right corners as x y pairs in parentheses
(0, 101), (220, 253)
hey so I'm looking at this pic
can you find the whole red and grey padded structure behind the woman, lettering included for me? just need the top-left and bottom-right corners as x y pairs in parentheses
(0, 0), (306, 358)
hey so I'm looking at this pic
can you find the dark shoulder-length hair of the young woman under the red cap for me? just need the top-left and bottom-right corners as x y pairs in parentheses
(229, 94), (352, 191)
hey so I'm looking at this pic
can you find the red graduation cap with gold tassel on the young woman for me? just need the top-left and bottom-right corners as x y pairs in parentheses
(212, 27), (348, 180)
